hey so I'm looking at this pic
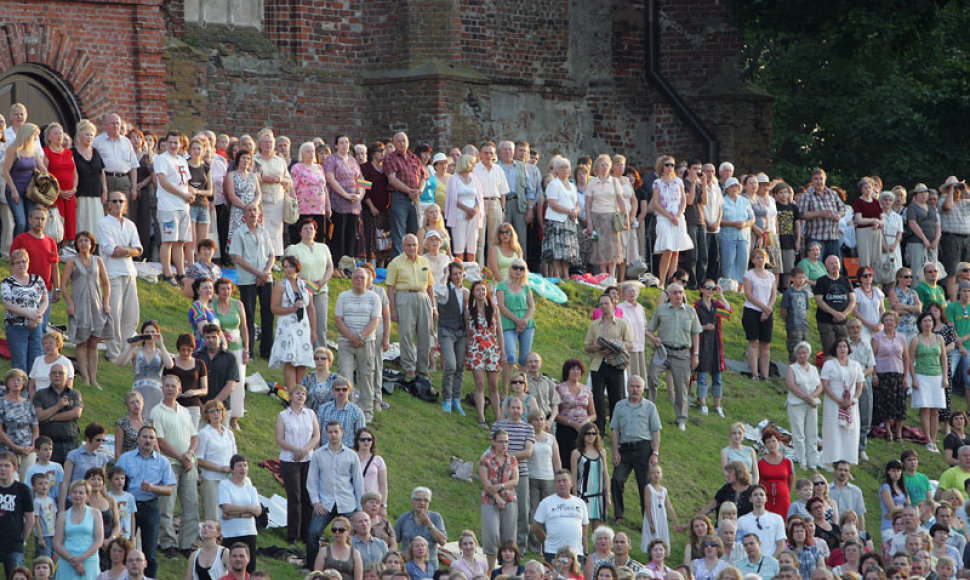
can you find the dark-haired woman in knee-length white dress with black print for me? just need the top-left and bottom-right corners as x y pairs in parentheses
(269, 256), (316, 388)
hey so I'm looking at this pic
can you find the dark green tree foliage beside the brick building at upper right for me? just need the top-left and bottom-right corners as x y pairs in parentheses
(735, 0), (970, 186)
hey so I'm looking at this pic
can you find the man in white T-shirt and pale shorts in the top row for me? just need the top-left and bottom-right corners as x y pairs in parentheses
(155, 131), (194, 286)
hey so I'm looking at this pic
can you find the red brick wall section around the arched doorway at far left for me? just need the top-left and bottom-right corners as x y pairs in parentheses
(0, 0), (168, 129)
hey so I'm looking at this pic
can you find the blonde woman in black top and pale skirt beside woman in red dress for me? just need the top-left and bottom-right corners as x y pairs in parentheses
(69, 119), (108, 232)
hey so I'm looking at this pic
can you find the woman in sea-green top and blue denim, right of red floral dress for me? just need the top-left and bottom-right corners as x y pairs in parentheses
(495, 258), (536, 390)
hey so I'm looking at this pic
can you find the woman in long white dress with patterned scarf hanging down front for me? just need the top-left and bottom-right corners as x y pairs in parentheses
(821, 338), (865, 465)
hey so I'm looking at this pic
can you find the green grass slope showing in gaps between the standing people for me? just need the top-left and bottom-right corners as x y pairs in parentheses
(11, 273), (948, 580)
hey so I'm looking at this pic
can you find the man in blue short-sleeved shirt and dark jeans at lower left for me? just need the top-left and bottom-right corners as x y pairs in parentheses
(115, 425), (175, 577)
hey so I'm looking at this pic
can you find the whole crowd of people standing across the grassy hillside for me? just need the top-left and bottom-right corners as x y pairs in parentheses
(0, 98), (970, 580)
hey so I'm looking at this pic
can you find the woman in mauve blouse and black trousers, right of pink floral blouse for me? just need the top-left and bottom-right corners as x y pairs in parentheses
(323, 135), (364, 261)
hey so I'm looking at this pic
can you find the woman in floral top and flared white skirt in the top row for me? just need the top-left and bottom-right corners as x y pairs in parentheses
(650, 155), (694, 285)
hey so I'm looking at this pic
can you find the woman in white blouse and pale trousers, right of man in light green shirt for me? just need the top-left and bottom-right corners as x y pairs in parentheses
(195, 399), (237, 520)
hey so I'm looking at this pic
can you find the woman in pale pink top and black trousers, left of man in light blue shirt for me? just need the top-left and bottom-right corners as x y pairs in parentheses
(276, 386), (320, 545)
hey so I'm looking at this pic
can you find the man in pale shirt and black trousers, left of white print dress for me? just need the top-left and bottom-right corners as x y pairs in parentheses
(229, 205), (276, 360)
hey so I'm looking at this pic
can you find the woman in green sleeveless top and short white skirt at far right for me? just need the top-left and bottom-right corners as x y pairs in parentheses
(909, 312), (949, 453)
